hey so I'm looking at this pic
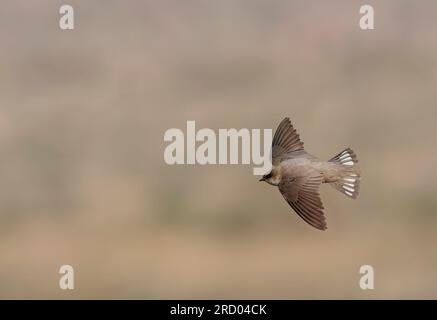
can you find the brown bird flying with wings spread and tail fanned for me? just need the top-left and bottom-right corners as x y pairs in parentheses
(260, 118), (360, 230)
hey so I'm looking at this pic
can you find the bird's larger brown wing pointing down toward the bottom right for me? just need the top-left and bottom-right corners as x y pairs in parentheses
(279, 175), (326, 230)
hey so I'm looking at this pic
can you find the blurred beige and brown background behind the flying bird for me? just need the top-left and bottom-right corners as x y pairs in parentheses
(0, 0), (437, 299)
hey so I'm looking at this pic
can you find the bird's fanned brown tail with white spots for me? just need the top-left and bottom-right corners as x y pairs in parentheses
(329, 148), (360, 199)
